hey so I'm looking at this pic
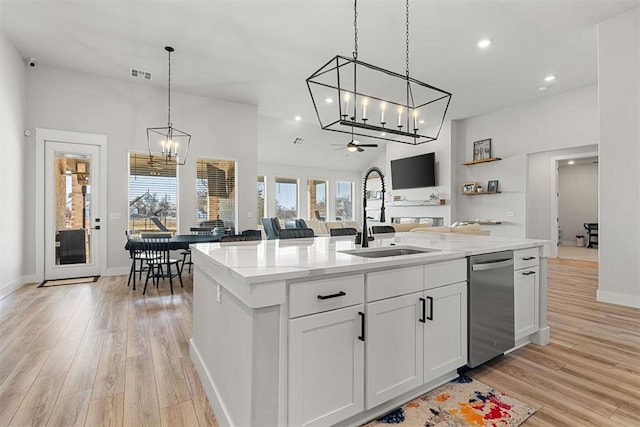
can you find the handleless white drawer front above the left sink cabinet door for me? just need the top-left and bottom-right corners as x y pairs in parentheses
(367, 265), (424, 302)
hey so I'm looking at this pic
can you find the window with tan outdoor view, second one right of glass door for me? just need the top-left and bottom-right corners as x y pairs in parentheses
(196, 158), (236, 228)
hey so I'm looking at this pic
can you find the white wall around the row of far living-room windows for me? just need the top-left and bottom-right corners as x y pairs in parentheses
(254, 163), (362, 224)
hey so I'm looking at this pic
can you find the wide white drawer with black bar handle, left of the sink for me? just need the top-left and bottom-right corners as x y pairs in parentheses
(289, 274), (364, 318)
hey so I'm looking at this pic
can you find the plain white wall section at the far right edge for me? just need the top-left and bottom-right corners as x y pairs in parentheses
(598, 8), (640, 307)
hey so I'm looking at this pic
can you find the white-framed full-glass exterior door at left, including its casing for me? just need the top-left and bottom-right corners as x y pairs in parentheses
(36, 129), (106, 280)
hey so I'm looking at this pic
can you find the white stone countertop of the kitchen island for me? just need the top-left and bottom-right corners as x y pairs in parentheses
(191, 232), (549, 284)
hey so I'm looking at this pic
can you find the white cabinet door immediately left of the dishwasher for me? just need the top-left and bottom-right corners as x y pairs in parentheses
(424, 282), (467, 382)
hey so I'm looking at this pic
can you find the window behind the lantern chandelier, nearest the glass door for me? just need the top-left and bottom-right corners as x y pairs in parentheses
(129, 153), (178, 231)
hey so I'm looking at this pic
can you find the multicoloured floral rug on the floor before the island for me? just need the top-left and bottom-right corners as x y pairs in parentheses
(366, 375), (535, 427)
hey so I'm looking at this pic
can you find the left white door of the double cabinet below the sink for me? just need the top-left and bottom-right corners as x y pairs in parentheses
(365, 292), (424, 409)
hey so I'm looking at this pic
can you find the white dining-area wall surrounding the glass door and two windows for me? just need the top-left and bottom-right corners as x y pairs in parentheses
(21, 66), (257, 274)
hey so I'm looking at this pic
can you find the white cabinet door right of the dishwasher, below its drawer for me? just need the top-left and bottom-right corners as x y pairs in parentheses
(513, 267), (540, 341)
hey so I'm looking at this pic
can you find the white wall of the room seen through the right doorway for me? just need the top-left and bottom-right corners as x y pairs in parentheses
(558, 163), (598, 245)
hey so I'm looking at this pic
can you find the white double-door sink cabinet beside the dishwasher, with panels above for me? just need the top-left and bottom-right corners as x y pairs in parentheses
(365, 260), (467, 409)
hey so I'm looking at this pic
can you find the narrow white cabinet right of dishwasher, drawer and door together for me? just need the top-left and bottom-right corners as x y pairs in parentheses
(513, 248), (540, 342)
